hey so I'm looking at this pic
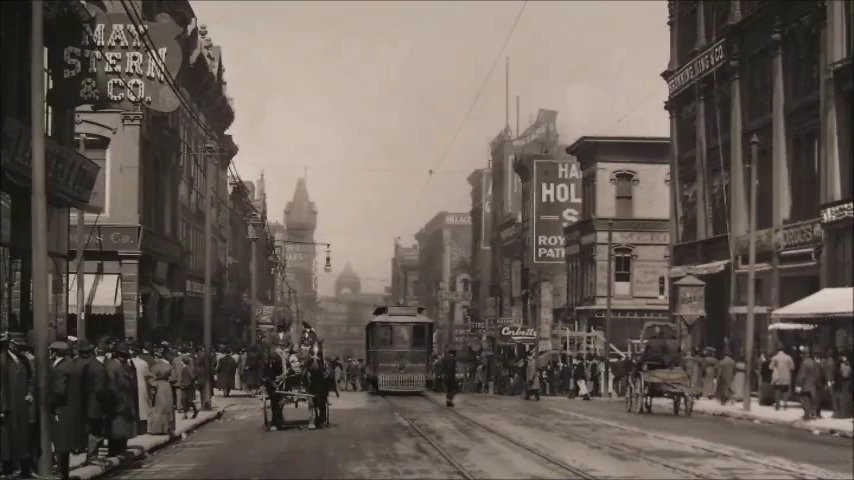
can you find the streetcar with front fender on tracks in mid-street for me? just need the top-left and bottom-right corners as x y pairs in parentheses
(365, 305), (433, 393)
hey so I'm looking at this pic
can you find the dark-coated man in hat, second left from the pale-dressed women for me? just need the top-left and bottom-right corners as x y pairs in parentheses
(76, 339), (113, 463)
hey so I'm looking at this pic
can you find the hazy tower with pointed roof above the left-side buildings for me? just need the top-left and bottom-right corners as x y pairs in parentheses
(282, 178), (323, 323)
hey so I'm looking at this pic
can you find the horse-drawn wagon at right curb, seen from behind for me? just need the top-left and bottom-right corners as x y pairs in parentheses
(626, 322), (694, 415)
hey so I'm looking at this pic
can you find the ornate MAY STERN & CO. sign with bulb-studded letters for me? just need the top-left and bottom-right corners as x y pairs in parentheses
(49, 4), (184, 113)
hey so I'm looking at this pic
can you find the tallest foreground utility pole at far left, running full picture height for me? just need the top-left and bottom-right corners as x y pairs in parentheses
(30, 0), (53, 477)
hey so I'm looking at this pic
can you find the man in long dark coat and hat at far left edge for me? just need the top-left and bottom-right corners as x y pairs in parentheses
(0, 332), (34, 477)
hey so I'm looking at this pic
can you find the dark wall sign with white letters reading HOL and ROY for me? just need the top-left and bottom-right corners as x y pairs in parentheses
(531, 160), (581, 263)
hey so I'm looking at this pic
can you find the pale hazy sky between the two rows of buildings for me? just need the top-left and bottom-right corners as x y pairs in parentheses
(193, 1), (669, 294)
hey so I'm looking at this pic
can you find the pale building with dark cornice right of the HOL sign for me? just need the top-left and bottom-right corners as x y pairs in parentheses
(564, 137), (670, 349)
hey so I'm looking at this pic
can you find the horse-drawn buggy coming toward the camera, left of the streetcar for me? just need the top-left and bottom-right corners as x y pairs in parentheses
(262, 323), (335, 431)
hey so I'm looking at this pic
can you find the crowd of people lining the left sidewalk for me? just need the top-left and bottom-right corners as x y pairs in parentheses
(0, 332), (280, 478)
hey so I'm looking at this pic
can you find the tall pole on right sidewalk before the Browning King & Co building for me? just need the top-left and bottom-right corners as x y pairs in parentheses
(744, 133), (759, 412)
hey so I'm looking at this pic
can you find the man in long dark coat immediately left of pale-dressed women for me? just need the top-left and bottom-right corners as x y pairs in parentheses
(104, 342), (139, 457)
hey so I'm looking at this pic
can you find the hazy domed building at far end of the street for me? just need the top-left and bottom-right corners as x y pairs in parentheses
(316, 262), (385, 359)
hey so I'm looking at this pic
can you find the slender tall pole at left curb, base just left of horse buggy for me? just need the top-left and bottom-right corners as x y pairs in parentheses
(202, 145), (218, 410)
